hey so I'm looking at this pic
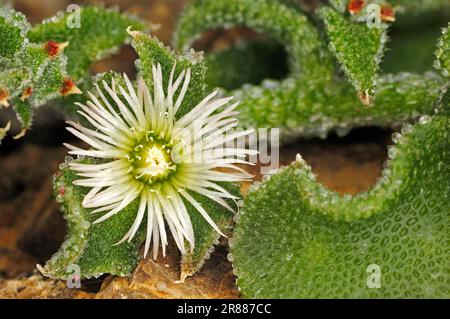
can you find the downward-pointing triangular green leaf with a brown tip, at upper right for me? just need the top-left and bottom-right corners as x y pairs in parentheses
(319, 7), (386, 104)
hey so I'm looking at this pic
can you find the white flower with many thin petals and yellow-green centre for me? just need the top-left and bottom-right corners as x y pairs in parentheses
(65, 65), (256, 258)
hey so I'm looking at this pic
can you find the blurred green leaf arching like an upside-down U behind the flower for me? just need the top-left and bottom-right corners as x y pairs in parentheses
(173, 0), (333, 78)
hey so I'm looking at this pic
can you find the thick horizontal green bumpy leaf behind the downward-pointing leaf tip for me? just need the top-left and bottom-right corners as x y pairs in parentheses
(230, 69), (442, 141)
